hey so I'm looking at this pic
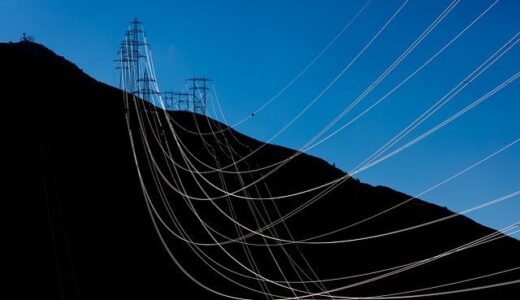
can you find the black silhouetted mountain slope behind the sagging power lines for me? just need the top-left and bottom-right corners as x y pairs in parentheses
(0, 42), (520, 299)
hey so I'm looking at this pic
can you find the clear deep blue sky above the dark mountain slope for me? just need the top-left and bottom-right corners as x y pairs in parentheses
(0, 0), (520, 237)
